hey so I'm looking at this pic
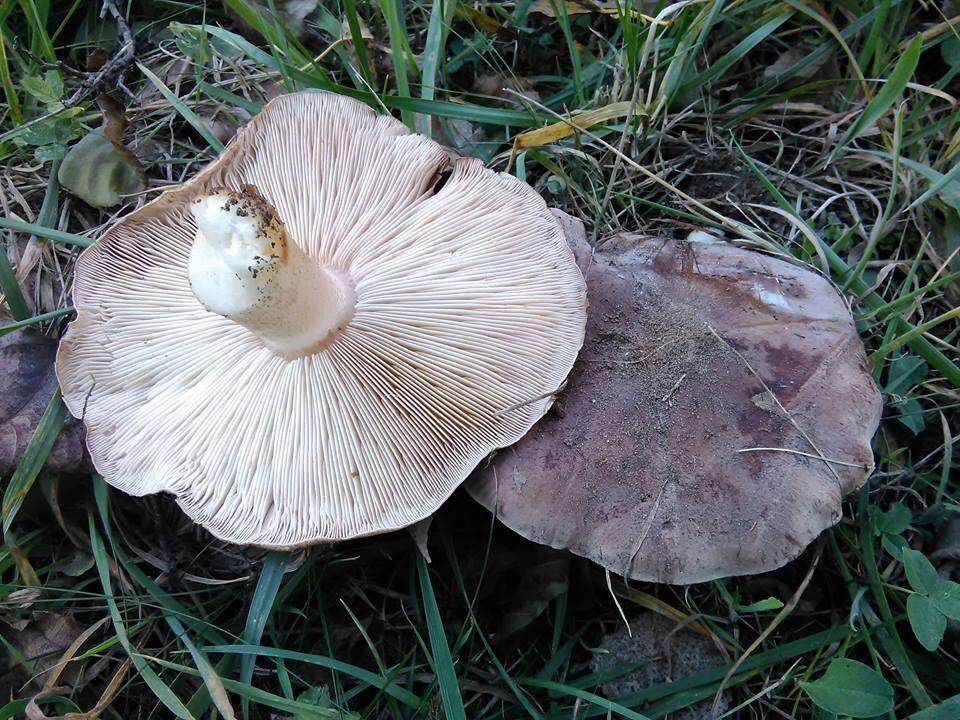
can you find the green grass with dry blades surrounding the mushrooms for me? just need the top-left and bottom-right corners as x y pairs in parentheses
(0, 0), (960, 720)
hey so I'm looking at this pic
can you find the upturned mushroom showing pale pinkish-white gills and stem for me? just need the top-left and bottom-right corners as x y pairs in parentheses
(57, 92), (586, 548)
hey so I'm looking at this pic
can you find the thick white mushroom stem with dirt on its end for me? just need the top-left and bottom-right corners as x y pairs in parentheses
(188, 185), (356, 358)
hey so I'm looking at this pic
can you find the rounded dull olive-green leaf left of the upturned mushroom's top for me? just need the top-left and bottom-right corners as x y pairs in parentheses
(57, 130), (147, 208)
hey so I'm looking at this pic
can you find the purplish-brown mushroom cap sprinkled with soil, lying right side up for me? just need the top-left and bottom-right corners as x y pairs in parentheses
(466, 231), (881, 584)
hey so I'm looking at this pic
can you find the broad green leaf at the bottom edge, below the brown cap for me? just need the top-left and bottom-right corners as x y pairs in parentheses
(800, 658), (893, 718)
